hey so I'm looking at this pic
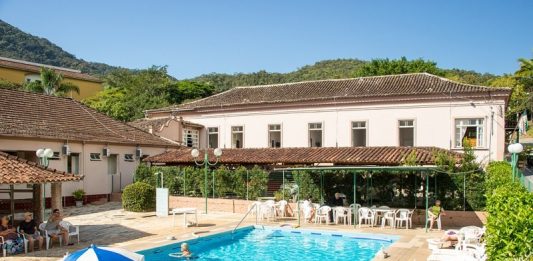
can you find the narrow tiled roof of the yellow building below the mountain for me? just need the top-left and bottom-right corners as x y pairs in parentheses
(0, 57), (103, 83)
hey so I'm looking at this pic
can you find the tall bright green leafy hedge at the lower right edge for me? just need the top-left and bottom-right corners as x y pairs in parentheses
(485, 162), (533, 260)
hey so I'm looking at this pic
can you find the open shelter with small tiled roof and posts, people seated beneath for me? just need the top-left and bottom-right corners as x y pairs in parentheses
(0, 152), (83, 222)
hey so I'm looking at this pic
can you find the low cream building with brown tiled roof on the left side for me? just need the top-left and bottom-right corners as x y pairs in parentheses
(0, 89), (178, 204)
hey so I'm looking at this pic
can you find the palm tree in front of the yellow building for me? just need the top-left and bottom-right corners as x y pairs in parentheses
(24, 67), (80, 96)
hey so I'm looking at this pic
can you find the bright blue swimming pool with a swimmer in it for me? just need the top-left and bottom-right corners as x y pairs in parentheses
(138, 226), (398, 261)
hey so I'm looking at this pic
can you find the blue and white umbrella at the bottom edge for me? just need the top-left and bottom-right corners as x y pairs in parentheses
(63, 245), (144, 261)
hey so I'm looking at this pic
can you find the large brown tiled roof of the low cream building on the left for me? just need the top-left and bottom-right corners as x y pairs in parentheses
(0, 88), (175, 146)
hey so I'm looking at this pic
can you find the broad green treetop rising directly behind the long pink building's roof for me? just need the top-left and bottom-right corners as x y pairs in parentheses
(354, 57), (443, 77)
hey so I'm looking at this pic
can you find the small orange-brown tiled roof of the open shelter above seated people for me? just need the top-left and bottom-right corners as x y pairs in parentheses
(0, 151), (83, 184)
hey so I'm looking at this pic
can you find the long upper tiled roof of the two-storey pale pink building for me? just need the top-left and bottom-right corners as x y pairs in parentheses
(152, 73), (511, 111)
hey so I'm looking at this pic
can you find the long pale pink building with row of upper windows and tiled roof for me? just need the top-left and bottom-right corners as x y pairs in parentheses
(146, 73), (510, 163)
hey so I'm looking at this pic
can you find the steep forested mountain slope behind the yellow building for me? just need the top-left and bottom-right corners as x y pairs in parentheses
(0, 20), (117, 76)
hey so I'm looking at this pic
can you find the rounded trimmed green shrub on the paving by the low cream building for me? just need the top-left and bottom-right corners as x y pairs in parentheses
(122, 182), (155, 212)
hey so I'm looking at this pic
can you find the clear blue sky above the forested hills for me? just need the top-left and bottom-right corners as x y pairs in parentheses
(0, 0), (533, 79)
